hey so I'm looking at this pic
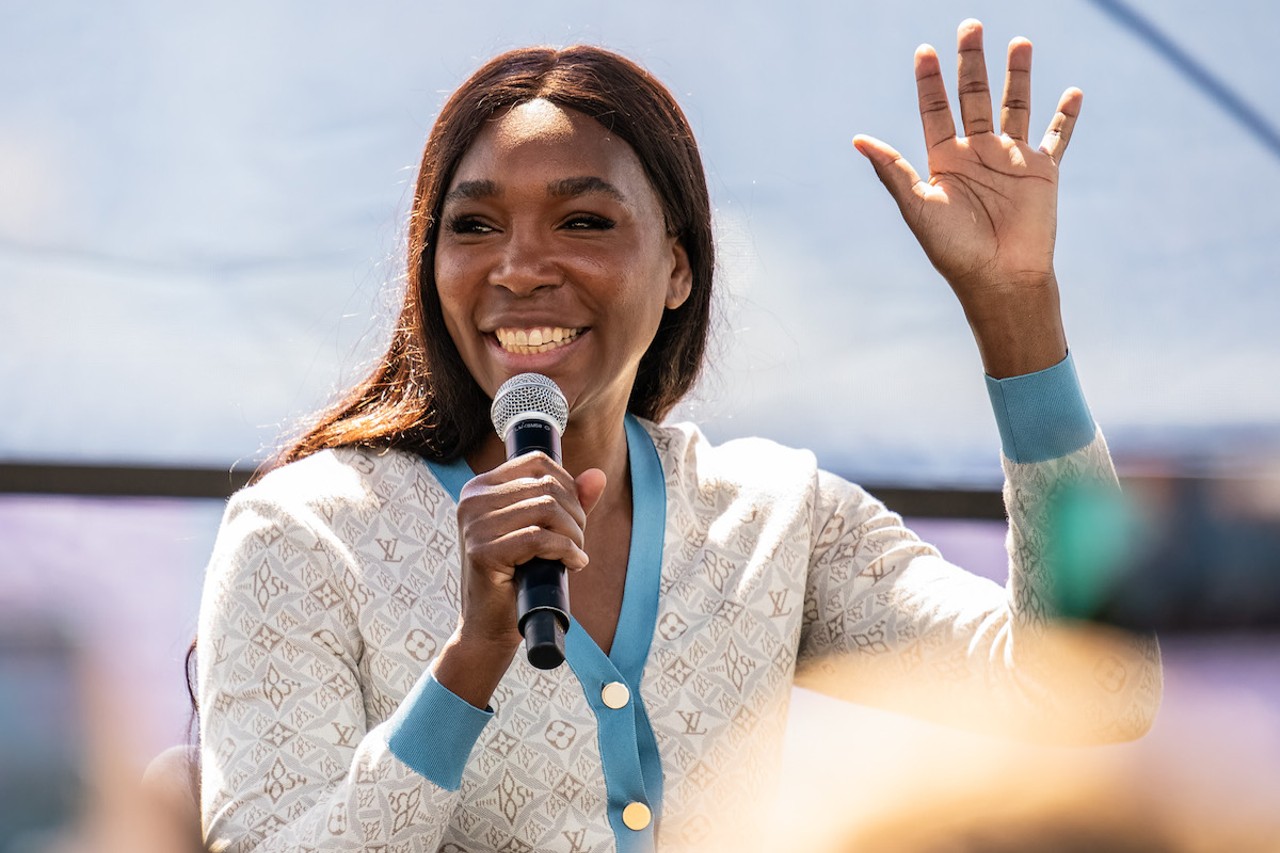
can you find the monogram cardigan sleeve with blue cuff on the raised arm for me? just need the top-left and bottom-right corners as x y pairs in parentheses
(800, 362), (1161, 742)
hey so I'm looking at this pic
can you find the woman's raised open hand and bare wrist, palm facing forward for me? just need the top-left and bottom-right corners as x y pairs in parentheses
(854, 19), (1084, 377)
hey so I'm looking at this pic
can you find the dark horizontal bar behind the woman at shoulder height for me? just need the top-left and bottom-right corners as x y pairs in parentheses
(0, 462), (1005, 519)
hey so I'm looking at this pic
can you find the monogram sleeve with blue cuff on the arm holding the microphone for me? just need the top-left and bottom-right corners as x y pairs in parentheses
(198, 494), (488, 853)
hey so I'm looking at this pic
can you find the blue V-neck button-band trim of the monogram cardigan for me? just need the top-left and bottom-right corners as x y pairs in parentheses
(428, 415), (667, 852)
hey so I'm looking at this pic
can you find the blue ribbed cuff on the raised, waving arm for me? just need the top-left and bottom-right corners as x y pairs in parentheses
(987, 353), (1097, 462)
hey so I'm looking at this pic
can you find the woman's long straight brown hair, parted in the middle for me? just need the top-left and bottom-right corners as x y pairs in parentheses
(273, 46), (716, 466)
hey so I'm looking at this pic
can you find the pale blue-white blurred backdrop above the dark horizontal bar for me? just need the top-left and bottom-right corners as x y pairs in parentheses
(0, 0), (1280, 480)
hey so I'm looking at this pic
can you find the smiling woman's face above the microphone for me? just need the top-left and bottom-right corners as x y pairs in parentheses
(435, 100), (692, 429)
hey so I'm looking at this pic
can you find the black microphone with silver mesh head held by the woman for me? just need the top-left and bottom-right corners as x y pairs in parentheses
(489, 373), (568, 670)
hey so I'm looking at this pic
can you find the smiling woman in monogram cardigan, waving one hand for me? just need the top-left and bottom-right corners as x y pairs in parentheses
(200, 22), (1160, 850)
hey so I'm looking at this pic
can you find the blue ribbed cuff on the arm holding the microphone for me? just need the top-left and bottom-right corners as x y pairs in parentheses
(387, 671), (493, 790)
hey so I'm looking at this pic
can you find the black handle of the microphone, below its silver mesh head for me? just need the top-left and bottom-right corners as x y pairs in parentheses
(506, 418), (568, 670)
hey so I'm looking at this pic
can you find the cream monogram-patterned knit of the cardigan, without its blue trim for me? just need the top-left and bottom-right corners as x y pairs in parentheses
(200, 424), (1160, 853)
